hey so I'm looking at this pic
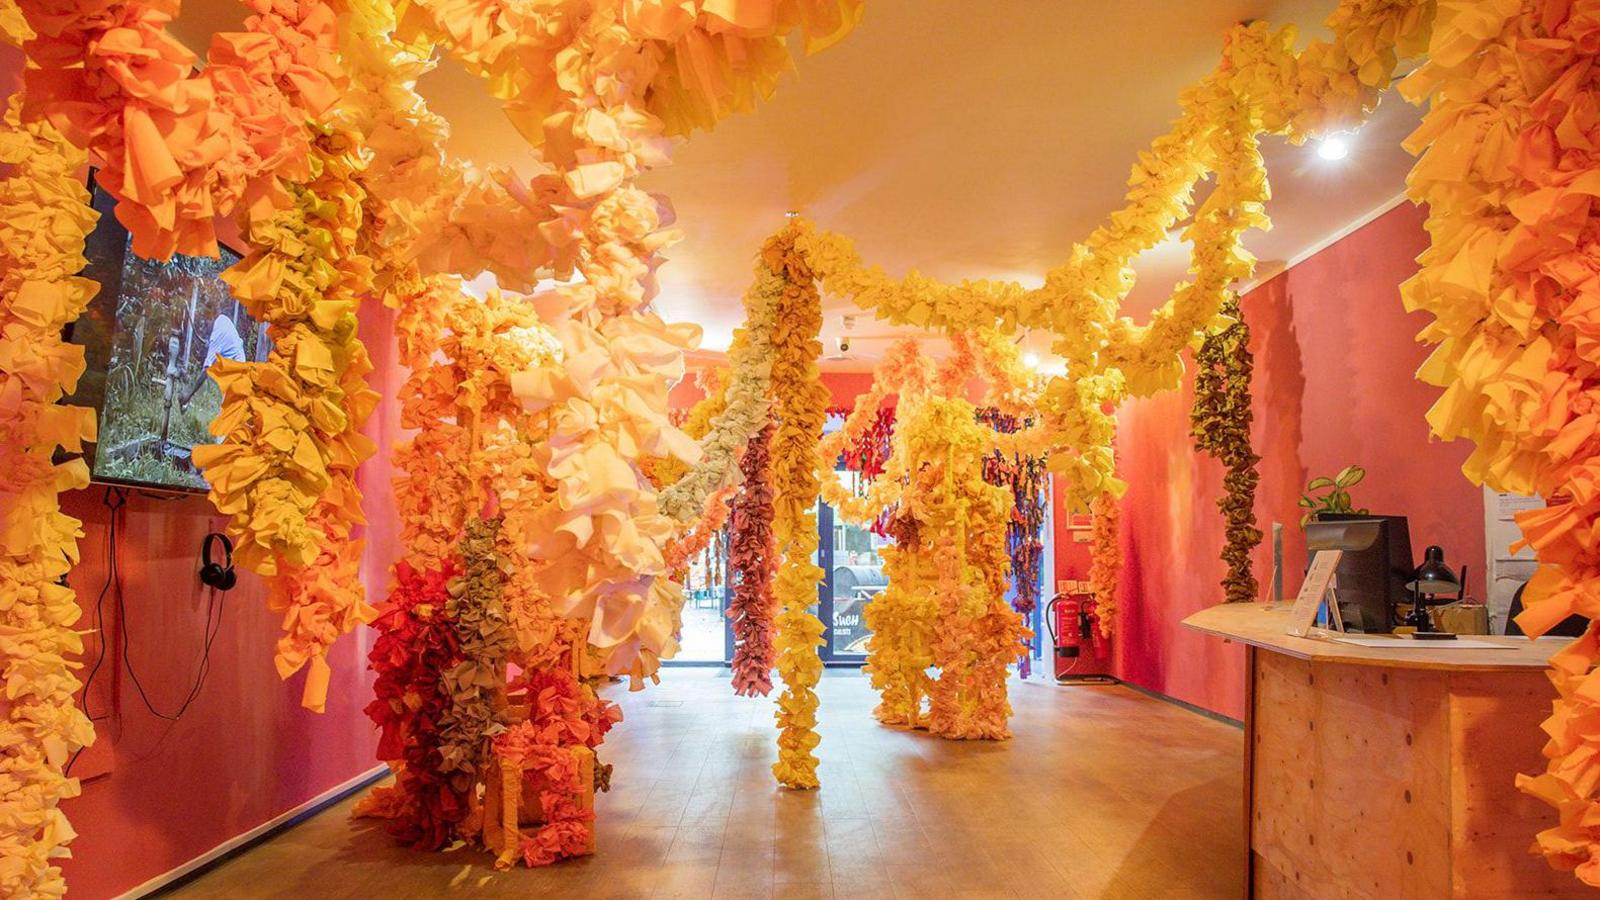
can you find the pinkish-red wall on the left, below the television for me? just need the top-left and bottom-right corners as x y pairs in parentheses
(62, 297), (403, 897)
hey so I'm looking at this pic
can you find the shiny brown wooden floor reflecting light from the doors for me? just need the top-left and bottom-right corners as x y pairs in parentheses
(176, 669), (1243, 900)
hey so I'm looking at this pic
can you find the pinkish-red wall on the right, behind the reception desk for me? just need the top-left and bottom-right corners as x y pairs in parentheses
(1100, 205), (1485, 717)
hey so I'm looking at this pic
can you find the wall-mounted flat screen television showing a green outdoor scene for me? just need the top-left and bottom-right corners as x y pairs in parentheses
(66, 176), (270, 492)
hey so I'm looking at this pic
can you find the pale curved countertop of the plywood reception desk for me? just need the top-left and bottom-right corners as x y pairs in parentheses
(1184, 604), (1570, 671)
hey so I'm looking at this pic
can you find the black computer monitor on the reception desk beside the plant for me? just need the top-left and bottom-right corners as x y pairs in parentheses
(1306, 512), (1416, 634)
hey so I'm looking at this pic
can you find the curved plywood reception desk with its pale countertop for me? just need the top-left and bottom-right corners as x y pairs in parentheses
(1184, 604), (1590, 897)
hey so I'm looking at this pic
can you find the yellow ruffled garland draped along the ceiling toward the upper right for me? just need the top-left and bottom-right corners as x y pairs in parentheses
(797, 0), (1434, 509)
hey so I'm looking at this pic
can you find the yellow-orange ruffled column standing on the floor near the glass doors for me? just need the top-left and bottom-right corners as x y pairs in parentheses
(822, 331), (1045, 740)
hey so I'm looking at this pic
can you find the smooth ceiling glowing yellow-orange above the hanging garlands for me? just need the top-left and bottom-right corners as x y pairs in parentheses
(179, 0), (1419, 368)
